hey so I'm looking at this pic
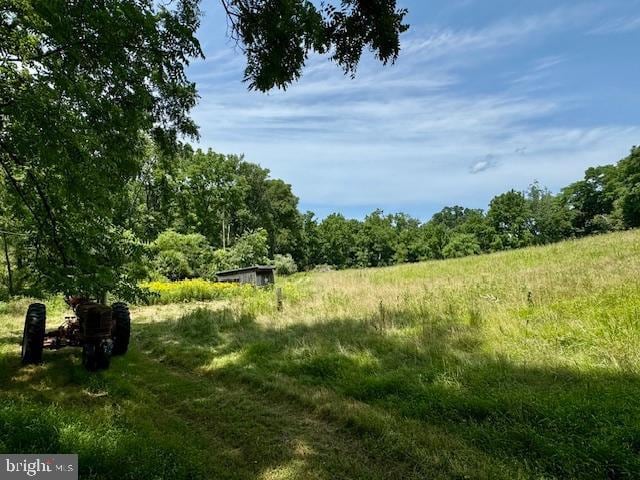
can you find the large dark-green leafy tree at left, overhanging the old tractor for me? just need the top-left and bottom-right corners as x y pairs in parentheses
(0, 0), (201, 295)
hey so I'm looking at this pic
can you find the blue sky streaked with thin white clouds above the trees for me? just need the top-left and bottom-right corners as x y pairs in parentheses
(189, 0), (640, 220)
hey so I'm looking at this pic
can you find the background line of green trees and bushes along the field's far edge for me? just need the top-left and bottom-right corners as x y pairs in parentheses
(0, 139), (640, 296)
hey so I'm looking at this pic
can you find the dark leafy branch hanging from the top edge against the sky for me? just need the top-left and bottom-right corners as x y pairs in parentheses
(222, 0), (409, 91)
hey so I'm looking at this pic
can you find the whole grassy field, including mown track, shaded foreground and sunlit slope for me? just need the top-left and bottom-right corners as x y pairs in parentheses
(0, 231), (640, 480)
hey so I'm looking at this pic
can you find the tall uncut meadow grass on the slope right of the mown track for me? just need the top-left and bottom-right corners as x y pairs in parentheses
(141, 231), (640, 478)
